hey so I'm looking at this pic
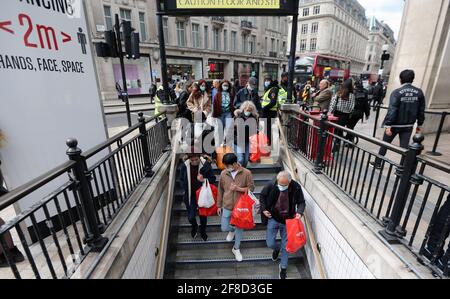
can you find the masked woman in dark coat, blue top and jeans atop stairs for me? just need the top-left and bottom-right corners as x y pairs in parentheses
(213, 80), (234, 132)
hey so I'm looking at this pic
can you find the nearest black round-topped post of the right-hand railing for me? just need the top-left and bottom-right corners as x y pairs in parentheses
(381, 135), (424, 244)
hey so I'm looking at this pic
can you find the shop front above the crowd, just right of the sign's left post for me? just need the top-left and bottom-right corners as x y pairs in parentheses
(167, 56), (203, 81)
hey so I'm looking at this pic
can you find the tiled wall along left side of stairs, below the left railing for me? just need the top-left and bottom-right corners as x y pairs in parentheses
(122, 193), (166, 279)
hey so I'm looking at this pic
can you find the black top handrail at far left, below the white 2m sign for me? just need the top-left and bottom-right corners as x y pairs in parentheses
(0, 161), (75, 211)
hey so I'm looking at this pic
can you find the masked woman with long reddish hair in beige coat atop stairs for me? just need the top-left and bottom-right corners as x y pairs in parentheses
(186, 80), (212, 122)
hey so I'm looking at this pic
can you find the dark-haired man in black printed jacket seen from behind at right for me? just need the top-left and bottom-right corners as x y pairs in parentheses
(371, 70), (425, 168)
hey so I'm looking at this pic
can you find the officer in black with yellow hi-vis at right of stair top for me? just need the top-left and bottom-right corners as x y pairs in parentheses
(261, 75), (280, 145)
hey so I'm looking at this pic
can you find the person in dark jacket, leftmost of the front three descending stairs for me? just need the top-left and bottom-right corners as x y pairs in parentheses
(178, 148), (216, 242)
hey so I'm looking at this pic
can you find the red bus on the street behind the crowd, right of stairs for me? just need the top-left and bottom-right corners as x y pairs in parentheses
(295, 54), (350, 83)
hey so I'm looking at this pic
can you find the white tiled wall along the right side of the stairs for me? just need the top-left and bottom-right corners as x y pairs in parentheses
(303, 190), (375, 279)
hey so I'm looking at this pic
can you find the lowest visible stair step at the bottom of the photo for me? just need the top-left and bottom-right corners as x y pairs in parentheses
(168, 258), (310, 280)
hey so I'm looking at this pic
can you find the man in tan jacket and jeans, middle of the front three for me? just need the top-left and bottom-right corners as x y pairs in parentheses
(217, 154), (255, 262)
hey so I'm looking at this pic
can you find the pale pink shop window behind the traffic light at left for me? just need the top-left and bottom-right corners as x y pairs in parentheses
(112, 55), (152, 97)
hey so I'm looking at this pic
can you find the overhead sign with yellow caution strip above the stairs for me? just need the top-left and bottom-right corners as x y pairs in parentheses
(158, 0), (298, 16)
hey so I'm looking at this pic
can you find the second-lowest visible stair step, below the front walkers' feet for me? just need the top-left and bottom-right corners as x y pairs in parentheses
(175, 243), (301, 264)
